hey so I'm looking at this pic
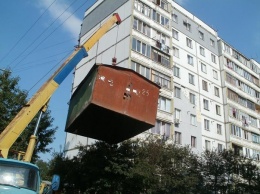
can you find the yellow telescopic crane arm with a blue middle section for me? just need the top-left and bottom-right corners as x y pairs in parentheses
(0, 14), (121, 158)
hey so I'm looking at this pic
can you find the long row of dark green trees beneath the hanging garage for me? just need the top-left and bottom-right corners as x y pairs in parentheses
(47, 139), (260, 194)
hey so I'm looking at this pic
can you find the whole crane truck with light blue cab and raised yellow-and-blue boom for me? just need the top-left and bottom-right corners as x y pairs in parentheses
(0, 13), (121, 194)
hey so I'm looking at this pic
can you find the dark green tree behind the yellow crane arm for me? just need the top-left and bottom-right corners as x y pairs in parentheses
(0, 71), (57, 162)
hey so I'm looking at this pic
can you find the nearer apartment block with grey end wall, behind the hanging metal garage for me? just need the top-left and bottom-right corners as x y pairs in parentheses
(65, 0), (259, 157)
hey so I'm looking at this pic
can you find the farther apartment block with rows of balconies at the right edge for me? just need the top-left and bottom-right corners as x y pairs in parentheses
(218, 39), (260, 161)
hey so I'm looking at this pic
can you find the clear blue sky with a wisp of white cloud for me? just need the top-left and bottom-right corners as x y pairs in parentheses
(0, 0), (260, 161)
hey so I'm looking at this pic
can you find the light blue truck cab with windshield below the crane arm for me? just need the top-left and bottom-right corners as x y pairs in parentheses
(0, 158), (41, 194)
